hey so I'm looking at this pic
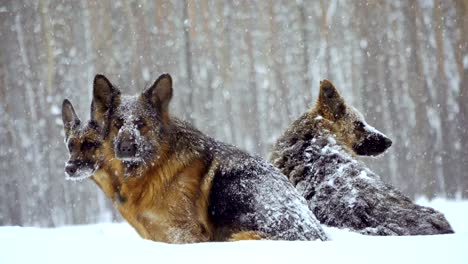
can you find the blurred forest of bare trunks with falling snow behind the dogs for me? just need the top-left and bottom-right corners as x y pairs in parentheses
(0, 0), (468, 226)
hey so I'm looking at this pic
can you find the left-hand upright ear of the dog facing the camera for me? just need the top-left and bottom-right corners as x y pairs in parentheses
(91, 74), (120, 123)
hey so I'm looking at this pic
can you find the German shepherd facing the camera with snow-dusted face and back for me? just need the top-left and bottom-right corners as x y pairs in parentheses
(92, 74), (327, 243)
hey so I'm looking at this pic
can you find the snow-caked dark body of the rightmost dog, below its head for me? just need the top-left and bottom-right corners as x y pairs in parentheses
(270, 113), (453, 235)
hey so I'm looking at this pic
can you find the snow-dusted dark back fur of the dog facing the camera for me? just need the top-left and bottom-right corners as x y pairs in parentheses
(173, 118), (327, 240)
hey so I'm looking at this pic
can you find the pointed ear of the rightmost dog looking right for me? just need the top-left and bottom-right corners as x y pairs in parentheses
(317, 80), (346, 120)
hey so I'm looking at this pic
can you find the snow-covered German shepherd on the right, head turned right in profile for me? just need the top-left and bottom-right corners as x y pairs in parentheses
(269, 80), (453, 235)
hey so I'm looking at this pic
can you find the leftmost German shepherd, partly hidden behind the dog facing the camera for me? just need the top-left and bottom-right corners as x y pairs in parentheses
(62, 92), (147, 238)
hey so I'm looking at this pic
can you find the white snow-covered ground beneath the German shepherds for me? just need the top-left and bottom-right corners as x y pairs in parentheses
(0, 199), (468, 264)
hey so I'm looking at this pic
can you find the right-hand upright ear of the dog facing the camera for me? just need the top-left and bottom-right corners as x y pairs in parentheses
(143, 74), (172, 113)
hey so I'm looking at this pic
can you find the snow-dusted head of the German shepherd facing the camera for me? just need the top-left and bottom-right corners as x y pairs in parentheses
(93, 74), (172, 173)
